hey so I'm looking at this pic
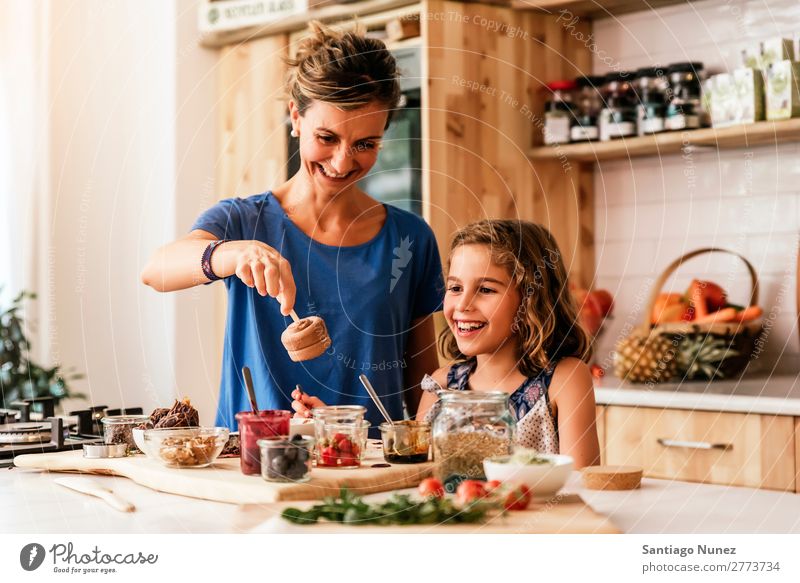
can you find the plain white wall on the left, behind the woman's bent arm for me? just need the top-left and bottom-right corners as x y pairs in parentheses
(3, 0), (221, 423)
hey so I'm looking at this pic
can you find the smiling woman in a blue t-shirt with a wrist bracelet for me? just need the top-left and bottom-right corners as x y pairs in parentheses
(142, 22), (444, 429)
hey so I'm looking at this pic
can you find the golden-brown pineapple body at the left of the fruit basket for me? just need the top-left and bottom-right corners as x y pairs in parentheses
(614, 330), (678, 383)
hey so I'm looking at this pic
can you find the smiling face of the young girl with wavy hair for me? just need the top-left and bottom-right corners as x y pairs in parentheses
(444, 245), (521, 356)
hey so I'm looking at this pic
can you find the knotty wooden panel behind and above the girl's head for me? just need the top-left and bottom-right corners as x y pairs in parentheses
(422, 0), (594, 285)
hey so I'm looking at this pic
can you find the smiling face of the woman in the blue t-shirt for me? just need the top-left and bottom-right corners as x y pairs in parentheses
(289, 101), (388, 195)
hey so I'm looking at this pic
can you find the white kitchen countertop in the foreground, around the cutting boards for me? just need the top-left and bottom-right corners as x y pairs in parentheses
(0, 468), (800, 534)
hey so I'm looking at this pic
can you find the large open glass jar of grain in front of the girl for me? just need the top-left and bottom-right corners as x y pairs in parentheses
(432, 391), (516, 483)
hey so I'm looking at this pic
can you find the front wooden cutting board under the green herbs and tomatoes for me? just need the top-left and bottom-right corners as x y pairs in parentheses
(238, 494), (620, 534)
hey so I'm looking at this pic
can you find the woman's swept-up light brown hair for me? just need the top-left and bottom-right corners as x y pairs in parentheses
(286, 20), (400, 127)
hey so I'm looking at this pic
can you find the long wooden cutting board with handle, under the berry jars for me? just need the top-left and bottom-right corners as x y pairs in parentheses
(14, 448), (433, 504)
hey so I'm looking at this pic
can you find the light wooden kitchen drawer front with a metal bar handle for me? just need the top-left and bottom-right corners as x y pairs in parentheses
(605, 406), (796, 491)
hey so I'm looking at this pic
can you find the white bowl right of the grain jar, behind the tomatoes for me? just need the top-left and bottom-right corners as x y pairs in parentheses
(483, 453), (574, 500)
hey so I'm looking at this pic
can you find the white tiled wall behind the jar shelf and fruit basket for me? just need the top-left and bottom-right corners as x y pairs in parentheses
(594, 0), (800, 374)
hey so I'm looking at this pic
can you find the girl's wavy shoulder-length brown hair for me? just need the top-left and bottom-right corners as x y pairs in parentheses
(439, 220), (591, 377)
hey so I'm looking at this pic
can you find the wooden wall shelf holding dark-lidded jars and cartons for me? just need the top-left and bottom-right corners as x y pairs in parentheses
(528, 119), (800, 162)
